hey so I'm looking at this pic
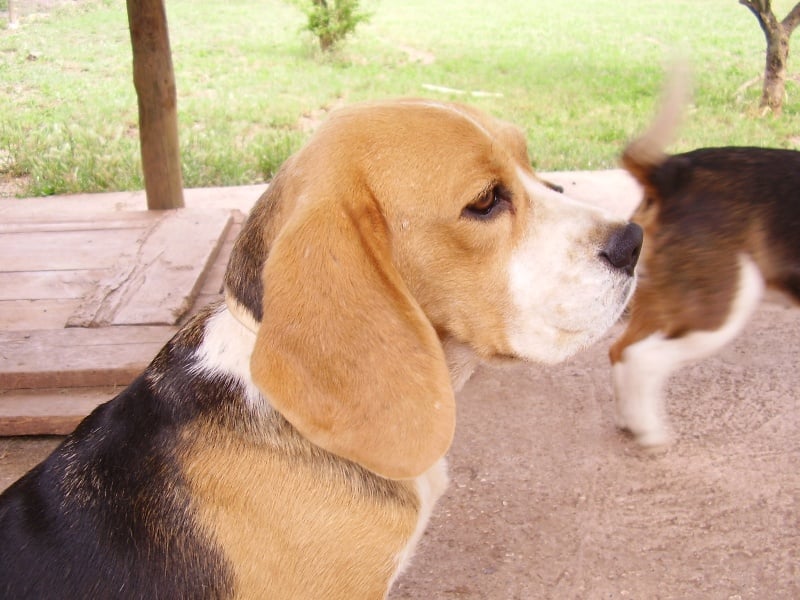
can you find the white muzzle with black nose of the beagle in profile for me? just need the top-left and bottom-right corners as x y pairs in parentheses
(509, 174), (643, 363)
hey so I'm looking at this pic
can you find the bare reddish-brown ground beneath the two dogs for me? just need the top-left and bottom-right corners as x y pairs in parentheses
(0, 172), (800, 600)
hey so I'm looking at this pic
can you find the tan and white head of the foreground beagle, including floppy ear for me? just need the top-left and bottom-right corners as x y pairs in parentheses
(226, 100), (641, 478)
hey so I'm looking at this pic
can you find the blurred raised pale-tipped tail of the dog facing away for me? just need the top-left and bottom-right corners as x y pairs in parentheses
(620, 61), (690, 182)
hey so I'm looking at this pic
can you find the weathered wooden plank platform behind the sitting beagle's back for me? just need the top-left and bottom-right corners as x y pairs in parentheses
(0, 208), (234, 435)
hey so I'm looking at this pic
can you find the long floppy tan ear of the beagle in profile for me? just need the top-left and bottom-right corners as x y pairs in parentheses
(251, 188), (455, 479)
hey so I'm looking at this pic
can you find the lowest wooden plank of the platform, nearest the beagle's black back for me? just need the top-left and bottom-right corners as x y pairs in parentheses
(0, 387), (123, 436)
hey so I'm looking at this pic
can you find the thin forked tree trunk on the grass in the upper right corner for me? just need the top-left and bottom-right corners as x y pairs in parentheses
(739, 0), (800, 115)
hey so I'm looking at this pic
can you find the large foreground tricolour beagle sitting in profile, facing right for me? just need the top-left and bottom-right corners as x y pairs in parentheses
(0, 99), (642, 600)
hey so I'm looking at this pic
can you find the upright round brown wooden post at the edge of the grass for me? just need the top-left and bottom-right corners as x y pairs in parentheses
(127, 0), (184, 209)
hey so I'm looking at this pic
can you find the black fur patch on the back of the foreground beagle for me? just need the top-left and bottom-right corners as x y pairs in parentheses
(0, 314), (231, 600)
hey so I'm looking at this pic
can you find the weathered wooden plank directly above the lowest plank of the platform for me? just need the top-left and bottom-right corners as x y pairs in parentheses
(0, 326), (177, 390)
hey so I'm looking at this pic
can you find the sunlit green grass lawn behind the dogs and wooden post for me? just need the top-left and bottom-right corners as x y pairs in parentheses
(0, 0), (800, 195)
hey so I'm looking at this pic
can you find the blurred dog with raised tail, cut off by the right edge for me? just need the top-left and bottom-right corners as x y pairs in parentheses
(609, 71), (800, 446)
